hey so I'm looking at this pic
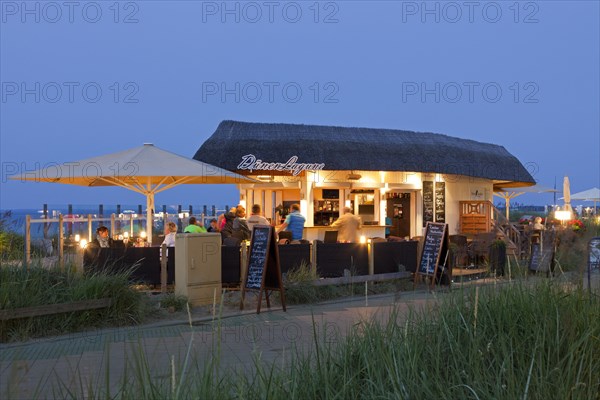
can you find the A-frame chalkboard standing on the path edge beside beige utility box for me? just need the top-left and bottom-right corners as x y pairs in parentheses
(240, 225), (286, 313)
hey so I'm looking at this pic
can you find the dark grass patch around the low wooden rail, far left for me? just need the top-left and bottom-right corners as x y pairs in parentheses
(0, 265), (149, 342)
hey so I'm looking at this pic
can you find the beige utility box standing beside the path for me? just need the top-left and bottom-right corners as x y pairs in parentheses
(175, 233), (221, 306)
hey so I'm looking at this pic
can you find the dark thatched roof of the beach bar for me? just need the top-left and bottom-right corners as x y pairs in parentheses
(194, 121), (535, 184)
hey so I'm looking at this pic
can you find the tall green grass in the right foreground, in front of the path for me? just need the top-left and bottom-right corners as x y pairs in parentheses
(52, 282), (600, 400)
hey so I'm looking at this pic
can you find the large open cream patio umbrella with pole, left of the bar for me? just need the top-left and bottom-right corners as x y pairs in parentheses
(11, 143), (255, 243)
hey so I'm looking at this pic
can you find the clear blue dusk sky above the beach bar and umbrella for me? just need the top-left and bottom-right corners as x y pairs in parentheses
(0, 0), (600, 209)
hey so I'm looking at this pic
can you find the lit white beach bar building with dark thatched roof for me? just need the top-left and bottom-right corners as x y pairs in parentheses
(194, 121), (535, 240)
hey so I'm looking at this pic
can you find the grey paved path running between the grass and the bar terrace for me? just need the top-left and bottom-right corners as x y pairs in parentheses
(0, 273), (600, 399)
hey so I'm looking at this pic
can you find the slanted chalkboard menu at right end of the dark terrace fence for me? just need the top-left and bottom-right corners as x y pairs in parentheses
(415, 222), (449, 279)
